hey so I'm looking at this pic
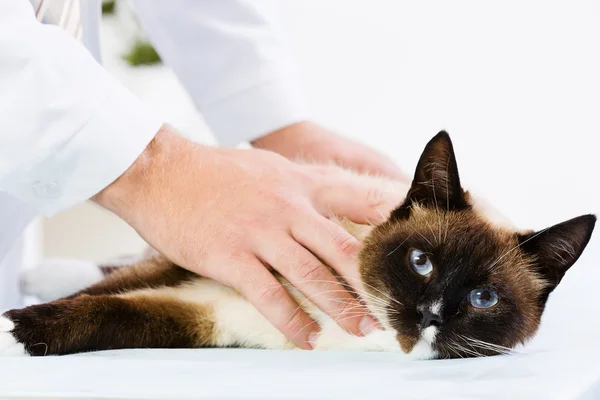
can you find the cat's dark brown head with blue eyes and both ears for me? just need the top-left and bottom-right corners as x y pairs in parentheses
(360, 132), (596, 358)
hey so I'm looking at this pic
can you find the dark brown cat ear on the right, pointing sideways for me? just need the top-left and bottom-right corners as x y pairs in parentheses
(519, 214), (596, 297)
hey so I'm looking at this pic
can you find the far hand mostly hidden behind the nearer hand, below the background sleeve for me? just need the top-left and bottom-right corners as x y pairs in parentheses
(252, 121), (411, 183)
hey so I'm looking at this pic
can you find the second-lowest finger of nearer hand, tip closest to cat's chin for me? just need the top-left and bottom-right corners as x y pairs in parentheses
(259, 238), (371, 335)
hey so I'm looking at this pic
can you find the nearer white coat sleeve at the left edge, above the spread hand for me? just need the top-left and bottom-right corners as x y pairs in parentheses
(0, 0), (162, 215)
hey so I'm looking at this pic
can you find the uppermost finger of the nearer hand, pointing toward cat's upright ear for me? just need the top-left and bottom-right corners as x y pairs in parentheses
(313, 175), (406, 224)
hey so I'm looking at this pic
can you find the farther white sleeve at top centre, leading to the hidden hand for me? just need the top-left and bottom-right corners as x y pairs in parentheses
(135, 0), (308, 146)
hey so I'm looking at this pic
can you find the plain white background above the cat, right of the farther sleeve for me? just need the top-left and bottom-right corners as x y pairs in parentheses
(286, 0), (600, 228)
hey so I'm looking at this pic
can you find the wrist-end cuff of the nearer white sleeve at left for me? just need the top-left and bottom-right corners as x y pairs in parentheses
(6, 87), (163, 217)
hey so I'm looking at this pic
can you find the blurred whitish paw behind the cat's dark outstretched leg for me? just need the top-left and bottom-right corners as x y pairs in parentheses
(21, 259), (103, 302)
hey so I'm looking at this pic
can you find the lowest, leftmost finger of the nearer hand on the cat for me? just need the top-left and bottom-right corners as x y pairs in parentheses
(228, 259), (320, 350)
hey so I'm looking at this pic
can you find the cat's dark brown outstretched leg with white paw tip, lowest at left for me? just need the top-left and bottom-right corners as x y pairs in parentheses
(0, 293), (216, 356)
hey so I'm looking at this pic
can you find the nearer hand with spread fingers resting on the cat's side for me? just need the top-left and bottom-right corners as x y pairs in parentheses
(93, 126), (403, 349)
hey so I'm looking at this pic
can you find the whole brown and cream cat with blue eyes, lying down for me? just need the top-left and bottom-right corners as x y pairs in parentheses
(0, 131), (596, 359)
